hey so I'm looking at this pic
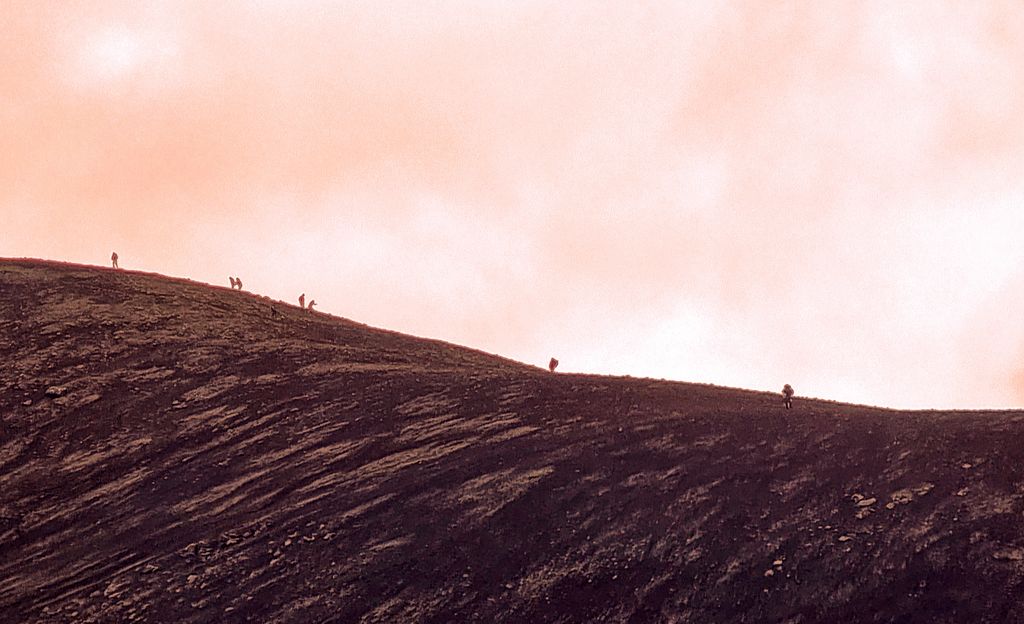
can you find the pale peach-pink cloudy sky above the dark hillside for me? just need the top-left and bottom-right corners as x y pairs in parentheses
(0, 0), (1024, 408)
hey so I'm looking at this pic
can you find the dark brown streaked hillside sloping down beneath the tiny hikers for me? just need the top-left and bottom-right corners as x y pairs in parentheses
(0, 260), (1024, 623)
